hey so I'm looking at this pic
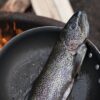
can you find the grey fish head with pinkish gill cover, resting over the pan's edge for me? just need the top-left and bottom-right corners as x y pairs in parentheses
(60, 11), (89, 51)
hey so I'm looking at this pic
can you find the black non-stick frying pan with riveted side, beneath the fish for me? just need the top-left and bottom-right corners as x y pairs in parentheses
(0, 26), (100, 100)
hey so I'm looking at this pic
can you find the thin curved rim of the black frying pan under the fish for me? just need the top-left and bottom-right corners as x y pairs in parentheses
(0, 26), (100, 55)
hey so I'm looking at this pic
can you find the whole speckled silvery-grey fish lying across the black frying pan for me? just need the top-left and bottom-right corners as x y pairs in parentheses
(31, 11), (89, 100)
